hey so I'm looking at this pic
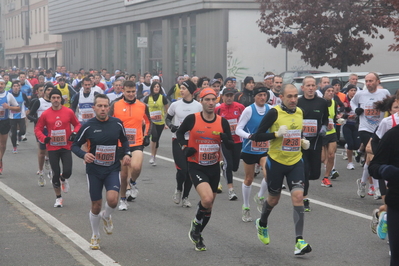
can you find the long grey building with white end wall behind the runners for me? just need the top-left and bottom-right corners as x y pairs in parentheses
(48, 0), (399, 90)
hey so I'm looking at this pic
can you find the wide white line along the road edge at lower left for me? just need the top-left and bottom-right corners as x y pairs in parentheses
(0, 182), (120, 265)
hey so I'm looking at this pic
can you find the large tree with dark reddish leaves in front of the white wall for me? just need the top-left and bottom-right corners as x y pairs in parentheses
(258, 0), (397, 72)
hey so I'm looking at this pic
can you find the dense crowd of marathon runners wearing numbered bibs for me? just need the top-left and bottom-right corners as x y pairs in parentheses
(0, 66), (399, 265)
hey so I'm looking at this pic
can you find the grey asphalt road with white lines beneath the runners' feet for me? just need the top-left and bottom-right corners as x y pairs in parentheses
(0, 124), (389, 266)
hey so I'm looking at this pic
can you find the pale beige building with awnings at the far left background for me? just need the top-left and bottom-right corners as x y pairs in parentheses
(1, 0), (62, 69)
